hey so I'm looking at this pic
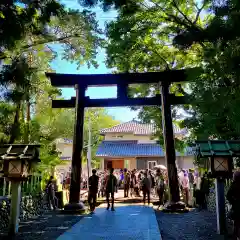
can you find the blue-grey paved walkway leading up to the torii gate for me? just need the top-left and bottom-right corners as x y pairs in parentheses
(57, 205), (161, 240)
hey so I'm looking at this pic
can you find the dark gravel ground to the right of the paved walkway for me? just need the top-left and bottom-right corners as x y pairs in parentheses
(156, 210), (230, 240)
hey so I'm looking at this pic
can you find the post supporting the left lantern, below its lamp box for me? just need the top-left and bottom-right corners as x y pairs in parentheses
(9, 181), (21, 235)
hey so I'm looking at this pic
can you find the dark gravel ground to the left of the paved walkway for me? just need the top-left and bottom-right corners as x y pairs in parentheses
(0, 212), (86, 240)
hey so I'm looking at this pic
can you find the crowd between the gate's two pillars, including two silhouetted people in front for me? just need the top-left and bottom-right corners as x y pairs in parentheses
(88, 169), (165, 211)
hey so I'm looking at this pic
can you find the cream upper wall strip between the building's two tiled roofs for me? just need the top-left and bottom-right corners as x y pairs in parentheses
(105, 133), (155, 143)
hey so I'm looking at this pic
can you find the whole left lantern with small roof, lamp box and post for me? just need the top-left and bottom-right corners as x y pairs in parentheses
(0, 144), (40, 235)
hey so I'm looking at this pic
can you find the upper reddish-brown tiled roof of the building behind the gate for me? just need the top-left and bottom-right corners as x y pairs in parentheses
(100, 120), (187, 135)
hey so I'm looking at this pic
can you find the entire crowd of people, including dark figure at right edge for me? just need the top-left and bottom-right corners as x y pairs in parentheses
(46, 169), (240, 239)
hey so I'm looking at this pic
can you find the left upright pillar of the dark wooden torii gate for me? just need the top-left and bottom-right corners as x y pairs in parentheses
(69, 86), (86, 204)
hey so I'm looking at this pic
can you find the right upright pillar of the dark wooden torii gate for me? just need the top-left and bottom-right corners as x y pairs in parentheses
(161, 82), (180, 202)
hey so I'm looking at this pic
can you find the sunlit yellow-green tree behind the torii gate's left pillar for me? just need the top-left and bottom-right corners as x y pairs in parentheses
(30, 86), (119, 174)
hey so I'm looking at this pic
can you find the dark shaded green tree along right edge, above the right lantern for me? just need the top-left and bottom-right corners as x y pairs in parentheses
(174, 0), (240, 140)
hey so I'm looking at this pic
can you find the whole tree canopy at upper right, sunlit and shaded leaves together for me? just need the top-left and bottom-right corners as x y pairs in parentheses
(84, 0), (240, 144)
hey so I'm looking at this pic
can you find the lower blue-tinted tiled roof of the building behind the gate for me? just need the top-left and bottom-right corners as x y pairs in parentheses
(96, 141), (193, 157)
